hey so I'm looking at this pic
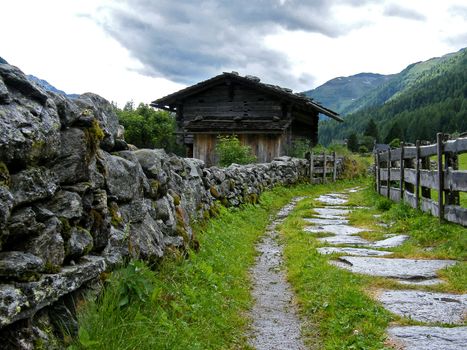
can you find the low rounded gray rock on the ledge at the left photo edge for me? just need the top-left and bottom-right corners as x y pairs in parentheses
(0, 251), (45, 278)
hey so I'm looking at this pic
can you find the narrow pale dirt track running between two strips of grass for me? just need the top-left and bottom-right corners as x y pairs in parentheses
(249, 197), (305, 350)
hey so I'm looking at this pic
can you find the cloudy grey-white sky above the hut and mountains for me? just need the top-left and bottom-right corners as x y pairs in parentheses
(0, 0), (467, 106)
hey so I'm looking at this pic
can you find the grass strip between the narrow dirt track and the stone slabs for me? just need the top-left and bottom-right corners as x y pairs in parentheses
(280, 179), (393, 349)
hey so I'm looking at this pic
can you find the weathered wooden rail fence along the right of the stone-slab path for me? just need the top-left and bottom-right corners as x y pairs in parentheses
(375, 133), (467, 226)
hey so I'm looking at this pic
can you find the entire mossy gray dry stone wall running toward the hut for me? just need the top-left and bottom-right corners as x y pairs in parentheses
(0, 64), (332, 349)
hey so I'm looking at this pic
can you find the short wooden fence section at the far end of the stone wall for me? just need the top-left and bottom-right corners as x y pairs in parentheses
(307, 152), (343, 184)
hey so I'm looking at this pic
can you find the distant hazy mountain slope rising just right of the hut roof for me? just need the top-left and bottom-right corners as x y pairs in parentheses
(304, 73), (392, 114)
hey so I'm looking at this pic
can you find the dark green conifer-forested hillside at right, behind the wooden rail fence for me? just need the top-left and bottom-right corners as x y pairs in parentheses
(320, 49), (467, 145)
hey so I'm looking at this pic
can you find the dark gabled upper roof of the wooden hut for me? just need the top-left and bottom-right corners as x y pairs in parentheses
(151, 72), (343, 122)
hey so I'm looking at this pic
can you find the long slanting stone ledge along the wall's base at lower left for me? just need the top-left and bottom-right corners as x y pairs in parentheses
(0, 256), (106, 327)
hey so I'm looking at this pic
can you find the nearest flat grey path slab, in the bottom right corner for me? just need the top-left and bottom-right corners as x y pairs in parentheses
(388, 326), (467, 350)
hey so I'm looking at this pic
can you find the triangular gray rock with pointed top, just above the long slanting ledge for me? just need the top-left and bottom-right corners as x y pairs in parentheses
(24, 217), (65, 267)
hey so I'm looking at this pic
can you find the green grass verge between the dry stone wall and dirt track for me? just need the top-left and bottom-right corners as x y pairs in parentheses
(74, 185), (340, 349)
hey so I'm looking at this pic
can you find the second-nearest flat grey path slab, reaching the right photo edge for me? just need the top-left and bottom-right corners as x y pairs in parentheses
(378, 290), (467, 322)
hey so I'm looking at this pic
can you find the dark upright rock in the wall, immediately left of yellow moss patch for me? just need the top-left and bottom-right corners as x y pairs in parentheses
(52, 128), (92, 184)
